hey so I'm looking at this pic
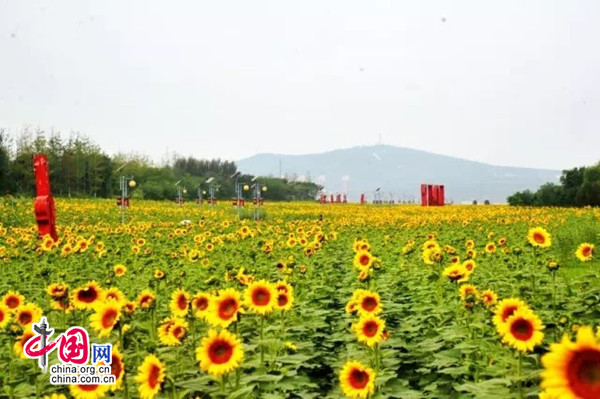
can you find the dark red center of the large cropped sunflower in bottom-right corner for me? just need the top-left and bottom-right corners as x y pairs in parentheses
(567, 348), (600, 399)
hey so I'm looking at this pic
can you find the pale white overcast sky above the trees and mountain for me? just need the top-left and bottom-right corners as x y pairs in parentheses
(0, 0), (600, 169)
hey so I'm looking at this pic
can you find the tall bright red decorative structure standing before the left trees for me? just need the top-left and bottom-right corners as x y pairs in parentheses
(33, 154), (58, 241)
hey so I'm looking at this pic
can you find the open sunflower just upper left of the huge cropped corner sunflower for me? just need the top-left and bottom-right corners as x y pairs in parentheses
(502, 309), (544, 352)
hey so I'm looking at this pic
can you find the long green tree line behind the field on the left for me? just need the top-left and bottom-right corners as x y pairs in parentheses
(0, 129), (322, 201)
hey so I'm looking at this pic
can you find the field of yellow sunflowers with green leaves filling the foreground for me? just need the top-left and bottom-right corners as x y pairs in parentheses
(0, 199), (600, 399)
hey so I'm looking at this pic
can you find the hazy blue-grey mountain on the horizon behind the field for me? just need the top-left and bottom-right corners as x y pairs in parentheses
(237, 145), (560, 203)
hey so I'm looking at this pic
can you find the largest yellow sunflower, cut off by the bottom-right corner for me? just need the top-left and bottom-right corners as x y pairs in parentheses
(541, 326), (600, 399)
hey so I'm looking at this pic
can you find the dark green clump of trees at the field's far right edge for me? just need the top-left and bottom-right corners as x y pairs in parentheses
(507, 162), (600, 206)
